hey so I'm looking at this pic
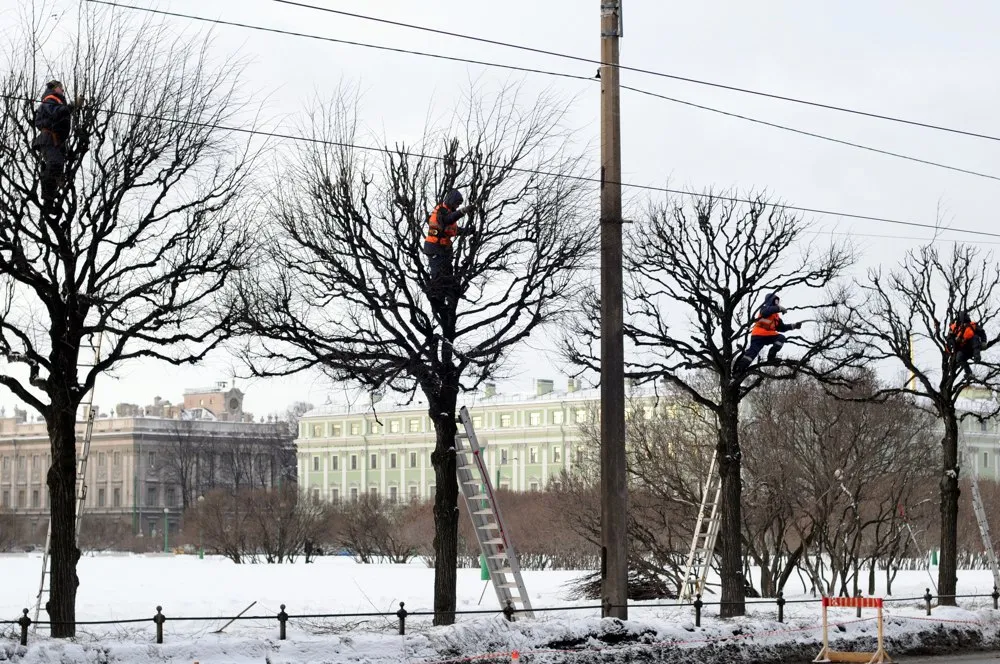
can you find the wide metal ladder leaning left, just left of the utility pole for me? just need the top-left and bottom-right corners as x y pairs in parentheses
(455, 406), (534, 618)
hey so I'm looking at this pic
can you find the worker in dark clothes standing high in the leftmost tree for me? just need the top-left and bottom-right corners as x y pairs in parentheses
(31, 80), (83, 211)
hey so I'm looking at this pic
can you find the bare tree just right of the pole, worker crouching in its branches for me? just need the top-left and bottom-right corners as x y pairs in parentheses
(565, 195), (852, 616)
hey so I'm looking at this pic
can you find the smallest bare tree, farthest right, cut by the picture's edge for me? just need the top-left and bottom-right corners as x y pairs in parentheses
(843, 244), (1000, 604)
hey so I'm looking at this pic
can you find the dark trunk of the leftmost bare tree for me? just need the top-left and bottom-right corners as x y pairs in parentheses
(45, 399), (80, 638)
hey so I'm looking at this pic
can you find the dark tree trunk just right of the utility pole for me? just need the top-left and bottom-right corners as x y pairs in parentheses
(717, 394), (746, 618)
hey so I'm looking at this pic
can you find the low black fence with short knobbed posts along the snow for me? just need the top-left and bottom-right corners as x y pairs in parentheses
(0, 586), (1000, 646)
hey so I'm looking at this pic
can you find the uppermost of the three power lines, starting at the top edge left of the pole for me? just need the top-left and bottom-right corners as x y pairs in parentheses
(274, 0), (1000, 141)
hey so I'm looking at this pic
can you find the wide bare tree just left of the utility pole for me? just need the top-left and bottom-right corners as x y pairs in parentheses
(241, 83), (593, 624)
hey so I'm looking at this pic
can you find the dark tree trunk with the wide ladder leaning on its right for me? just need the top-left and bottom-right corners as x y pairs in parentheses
(428, 386), (459, 625)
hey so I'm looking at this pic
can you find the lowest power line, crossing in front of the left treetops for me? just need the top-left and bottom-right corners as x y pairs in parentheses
(9, 94), (1000, 238)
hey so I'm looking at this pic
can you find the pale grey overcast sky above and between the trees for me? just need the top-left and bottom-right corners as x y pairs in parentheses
(0, 0), (1000, 414)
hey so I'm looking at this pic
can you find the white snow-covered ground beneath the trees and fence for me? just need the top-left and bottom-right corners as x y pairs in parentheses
(0, 554), (1000, 664)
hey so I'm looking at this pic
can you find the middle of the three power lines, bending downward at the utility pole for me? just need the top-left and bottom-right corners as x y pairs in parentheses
(87, 0), (1000, 181)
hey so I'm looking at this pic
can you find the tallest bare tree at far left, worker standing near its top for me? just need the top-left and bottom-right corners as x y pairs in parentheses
(0, 6), (251, 637)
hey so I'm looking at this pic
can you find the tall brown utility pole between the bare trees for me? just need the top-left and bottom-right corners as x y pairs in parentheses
(600, 0), (628, 620)
